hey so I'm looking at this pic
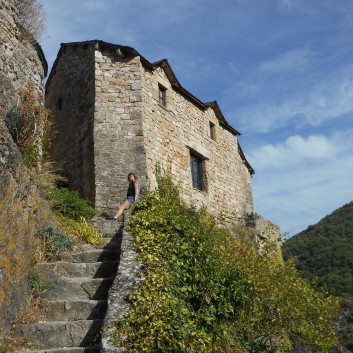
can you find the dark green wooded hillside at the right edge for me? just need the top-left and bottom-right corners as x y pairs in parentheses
(282, 202), (353, 295)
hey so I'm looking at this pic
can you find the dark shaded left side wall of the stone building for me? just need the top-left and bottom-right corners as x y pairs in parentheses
(45, 45), (95, 203)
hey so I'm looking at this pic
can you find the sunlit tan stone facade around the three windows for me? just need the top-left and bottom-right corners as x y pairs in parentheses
(142, 68), (253, 225)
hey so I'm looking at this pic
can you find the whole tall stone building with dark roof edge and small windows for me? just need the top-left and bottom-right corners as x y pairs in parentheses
(46, 40), (254, 224)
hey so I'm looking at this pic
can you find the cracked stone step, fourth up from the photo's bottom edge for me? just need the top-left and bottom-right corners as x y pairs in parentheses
(43, 277), (113, 300)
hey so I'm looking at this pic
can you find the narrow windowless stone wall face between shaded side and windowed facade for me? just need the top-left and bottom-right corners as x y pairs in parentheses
(94, 44), (146, 212)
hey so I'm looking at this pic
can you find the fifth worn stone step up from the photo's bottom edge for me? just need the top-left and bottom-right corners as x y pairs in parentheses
(37, 261), (118, 278)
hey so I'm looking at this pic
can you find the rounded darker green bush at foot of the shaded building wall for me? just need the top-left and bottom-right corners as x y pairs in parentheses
(49, 188), (95, 220)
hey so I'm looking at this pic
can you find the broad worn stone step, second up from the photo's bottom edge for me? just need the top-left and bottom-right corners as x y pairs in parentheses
(15, 320), (103, 351)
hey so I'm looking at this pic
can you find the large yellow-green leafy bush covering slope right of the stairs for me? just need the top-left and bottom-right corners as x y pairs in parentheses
(115, 178), (337, 353)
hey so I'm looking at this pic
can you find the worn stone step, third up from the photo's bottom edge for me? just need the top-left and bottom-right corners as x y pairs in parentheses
(42, 300), (108, 322)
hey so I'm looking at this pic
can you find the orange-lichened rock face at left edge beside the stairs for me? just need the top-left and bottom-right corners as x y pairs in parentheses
(0, 121), (35, 337)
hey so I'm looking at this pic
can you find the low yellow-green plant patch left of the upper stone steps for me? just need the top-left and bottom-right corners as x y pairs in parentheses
(57, 215), (102, 245)
